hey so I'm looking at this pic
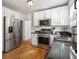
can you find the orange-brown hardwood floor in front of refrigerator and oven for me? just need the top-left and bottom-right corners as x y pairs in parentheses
(2, 41), (47, 59)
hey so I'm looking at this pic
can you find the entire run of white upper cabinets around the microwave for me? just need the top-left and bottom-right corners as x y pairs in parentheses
(34, 6), (69, 26)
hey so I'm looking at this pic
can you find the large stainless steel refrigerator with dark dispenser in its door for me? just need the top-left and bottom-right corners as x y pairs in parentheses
(3, 16), (22, 52)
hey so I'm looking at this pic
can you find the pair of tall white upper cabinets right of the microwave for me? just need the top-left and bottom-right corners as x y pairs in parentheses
(52, 6), (69, 26)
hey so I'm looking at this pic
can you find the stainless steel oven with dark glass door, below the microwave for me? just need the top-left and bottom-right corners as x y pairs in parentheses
(38, 34), (50, 47)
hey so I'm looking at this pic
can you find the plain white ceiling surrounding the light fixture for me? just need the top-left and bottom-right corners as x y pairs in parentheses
(2, 0), (68, 14)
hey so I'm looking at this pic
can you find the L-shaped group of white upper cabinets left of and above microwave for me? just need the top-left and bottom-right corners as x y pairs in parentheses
(33, 9), (52, 26)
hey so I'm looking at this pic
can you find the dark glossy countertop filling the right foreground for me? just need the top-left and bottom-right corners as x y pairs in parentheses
(45, 38), (77, 59)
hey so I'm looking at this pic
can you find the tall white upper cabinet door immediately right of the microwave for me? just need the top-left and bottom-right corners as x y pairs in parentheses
(52, 8), (60, 25)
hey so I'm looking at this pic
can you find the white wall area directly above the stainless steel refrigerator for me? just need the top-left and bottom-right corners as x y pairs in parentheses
(2, 6), (26, 20)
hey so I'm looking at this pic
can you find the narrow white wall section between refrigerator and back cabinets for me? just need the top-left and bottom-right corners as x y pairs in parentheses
(23, 14), (32, 41)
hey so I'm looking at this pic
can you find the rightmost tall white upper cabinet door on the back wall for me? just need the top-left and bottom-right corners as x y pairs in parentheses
(60, 6), (69, 25)
